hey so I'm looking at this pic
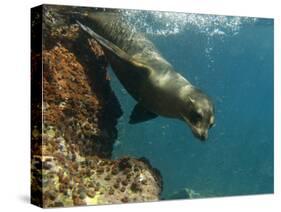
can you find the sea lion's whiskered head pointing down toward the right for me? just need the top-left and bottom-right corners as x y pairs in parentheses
(180, 87), (215, 141)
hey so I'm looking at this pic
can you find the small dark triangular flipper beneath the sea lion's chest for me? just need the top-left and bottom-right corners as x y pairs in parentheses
(129, 103), (158, 124)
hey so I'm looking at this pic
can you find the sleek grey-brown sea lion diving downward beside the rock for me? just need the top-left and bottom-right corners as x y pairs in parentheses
(76, 11), (215, 141)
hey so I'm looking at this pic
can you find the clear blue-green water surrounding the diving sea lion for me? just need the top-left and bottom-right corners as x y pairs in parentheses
(110, 13), (273, 198)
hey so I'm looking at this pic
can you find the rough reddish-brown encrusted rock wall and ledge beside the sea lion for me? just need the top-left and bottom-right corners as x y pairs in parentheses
(31, 6), (162, 207)
